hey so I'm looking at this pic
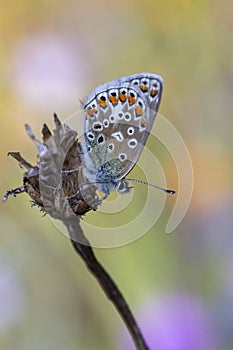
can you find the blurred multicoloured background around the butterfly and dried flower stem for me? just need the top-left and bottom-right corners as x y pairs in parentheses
(0, 0), (233, 350)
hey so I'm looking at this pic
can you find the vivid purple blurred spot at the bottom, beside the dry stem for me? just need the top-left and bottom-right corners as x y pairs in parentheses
(118, 293), (218, 350)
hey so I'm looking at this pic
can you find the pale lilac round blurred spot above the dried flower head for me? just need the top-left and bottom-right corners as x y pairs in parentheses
(8, 32), (86, 111)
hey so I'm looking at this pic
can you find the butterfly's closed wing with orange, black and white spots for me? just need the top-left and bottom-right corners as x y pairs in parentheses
(84, 73), (163, 182)
